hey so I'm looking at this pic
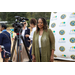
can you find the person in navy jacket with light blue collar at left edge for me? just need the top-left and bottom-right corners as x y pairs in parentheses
(0, 24), (11, 62)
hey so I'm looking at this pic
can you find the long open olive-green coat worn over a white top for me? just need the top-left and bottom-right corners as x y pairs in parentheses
(32, 29), (55, 62)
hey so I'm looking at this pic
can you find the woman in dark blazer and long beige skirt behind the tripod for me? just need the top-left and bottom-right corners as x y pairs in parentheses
(21, 20), (30, 61)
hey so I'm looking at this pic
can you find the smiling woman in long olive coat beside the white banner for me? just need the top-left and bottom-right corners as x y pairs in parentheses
(32, 18), (55, 62)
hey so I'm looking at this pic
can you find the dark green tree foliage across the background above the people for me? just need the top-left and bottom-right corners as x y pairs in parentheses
(0, 12), (51, 27)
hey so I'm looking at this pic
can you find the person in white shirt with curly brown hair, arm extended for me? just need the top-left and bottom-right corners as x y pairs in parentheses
(25, 18), (37, 59)
